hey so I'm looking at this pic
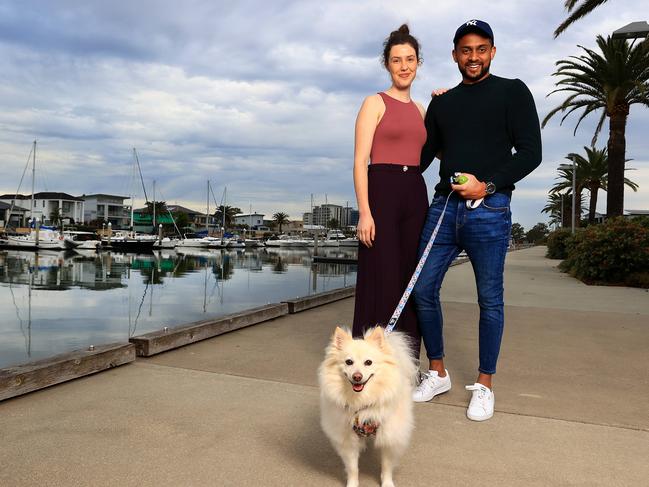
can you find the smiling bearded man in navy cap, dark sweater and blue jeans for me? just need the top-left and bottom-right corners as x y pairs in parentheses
(413, 20), (541, 421)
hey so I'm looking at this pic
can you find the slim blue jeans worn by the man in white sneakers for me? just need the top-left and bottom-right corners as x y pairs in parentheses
(413, 193), (511, 374)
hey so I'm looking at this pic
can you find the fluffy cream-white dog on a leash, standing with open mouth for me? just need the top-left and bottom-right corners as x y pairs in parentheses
(318, 327), (417, 487)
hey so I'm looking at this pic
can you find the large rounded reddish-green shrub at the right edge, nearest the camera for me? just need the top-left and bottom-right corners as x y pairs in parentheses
(560, 217), (649, 286)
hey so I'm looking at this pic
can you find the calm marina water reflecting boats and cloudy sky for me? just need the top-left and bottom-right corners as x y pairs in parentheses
(0, 249), (356, 367)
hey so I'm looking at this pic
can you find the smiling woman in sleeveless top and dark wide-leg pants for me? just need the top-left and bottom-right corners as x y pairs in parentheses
(353, 24), (428, 359)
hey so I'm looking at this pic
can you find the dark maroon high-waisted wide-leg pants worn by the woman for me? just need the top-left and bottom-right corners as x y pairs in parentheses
(352, 164), (428, 359)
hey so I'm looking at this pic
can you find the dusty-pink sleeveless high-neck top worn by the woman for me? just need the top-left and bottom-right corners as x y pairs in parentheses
(370, 93), (426, 166)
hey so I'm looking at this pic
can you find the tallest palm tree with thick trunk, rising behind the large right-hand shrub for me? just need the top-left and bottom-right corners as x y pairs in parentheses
(542, 36), (649, 217)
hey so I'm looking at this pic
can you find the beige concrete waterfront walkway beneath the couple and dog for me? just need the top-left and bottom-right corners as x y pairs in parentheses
(0, 247), (649, 487)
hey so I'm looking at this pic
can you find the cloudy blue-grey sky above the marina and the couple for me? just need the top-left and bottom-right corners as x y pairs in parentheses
(0, 0), (649, 228)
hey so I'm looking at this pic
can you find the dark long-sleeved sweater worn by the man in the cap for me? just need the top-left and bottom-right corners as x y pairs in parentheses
(421, 75), (541, 195)
